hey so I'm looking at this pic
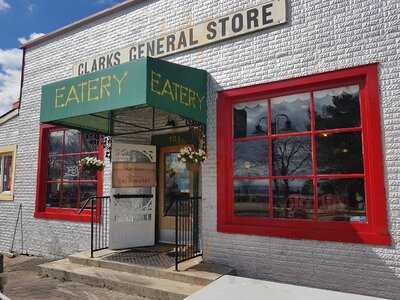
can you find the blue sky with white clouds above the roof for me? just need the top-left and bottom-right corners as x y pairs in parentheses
(0, 0), (122, 116)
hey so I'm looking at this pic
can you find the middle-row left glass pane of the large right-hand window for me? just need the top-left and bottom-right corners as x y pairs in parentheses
(233, 140), (268, 176)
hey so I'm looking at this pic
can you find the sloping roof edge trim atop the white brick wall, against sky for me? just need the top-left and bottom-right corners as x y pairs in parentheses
(20, 0), (143, 49)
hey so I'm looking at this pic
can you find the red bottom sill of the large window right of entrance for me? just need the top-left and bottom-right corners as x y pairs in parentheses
(217, 222), (391, 246)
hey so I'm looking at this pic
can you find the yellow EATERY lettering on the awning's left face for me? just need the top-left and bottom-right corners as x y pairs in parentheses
(54, 71), (129, 109)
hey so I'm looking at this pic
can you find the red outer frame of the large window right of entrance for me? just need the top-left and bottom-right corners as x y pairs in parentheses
(217, 64), (391, 245)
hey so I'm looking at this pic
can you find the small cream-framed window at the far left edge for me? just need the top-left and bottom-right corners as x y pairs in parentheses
(0, 146), (17, 200)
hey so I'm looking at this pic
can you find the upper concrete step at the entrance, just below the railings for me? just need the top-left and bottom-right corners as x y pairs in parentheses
(68, 250), (235, 286)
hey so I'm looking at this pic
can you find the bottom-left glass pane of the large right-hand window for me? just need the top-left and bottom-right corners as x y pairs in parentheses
(234, 180), (269, 217)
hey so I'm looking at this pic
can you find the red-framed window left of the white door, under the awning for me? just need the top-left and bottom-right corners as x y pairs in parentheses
(36, 125), (102, 221)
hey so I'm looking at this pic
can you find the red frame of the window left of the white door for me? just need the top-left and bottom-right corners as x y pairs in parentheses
(34, 124), (103, 222)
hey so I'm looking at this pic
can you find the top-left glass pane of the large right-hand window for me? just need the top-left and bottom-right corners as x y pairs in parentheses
(233, 101), (268, 138)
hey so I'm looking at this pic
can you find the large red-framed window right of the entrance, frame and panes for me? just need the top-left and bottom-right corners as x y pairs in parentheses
(218, 65), (389, 244)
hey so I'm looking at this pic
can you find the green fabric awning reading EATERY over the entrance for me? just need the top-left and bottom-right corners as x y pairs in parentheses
(40, 58), (207, 134)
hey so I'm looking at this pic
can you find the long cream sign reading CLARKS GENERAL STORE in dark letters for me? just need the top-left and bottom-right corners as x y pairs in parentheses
(73, 0), (286, 75)
